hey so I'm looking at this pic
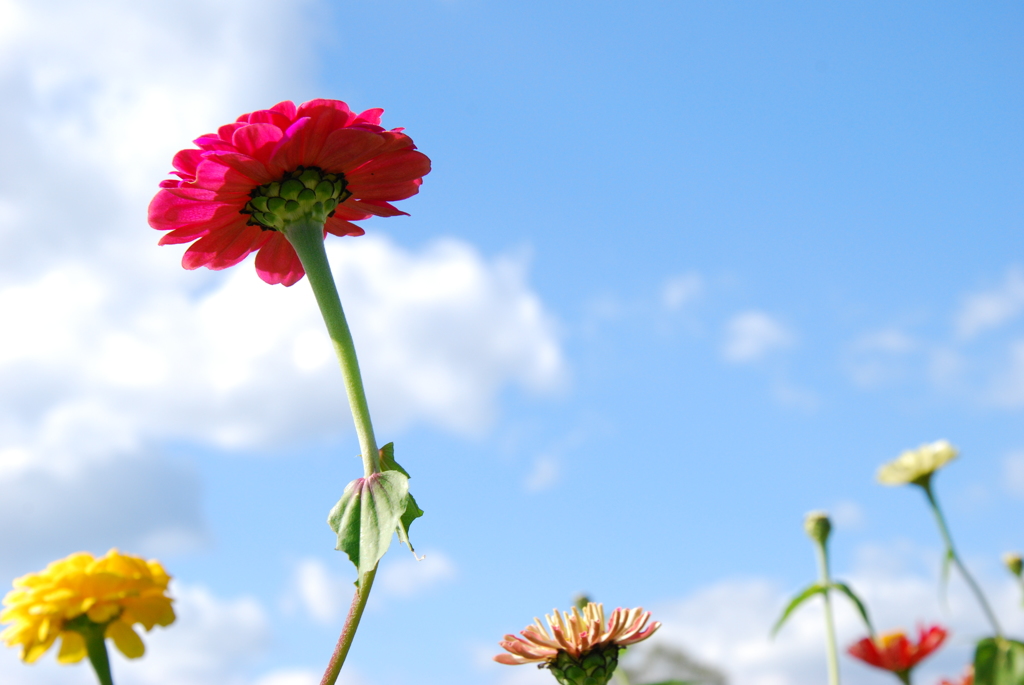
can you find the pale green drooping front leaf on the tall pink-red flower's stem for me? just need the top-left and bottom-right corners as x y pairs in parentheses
(327, 470), (410, 579)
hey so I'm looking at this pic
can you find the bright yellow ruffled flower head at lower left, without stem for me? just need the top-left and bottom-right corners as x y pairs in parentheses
(0, 550), (174, 663)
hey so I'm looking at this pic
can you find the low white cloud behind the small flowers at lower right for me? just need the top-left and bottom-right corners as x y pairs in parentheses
(637, 548), (1024, 685)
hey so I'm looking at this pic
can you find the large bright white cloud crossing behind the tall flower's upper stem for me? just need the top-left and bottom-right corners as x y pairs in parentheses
(0, 232), (563, 446)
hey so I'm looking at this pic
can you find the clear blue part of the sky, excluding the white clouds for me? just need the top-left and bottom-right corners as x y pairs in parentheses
(2, 0), (1024, 685)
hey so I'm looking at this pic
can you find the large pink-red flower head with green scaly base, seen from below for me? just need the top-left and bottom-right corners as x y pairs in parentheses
(150, 99), (430, 286)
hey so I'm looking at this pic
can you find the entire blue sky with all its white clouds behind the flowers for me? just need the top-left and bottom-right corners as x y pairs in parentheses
(0, 0), (1024, 685)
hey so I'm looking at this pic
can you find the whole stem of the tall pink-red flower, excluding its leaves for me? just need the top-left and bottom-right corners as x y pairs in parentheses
(284, 220), (381, 685)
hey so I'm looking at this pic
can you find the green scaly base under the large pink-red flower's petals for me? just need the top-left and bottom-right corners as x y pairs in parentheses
(242, 167), (352, 230)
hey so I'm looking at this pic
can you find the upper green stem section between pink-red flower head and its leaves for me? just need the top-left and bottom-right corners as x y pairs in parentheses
(285, 221), (380, 476)
